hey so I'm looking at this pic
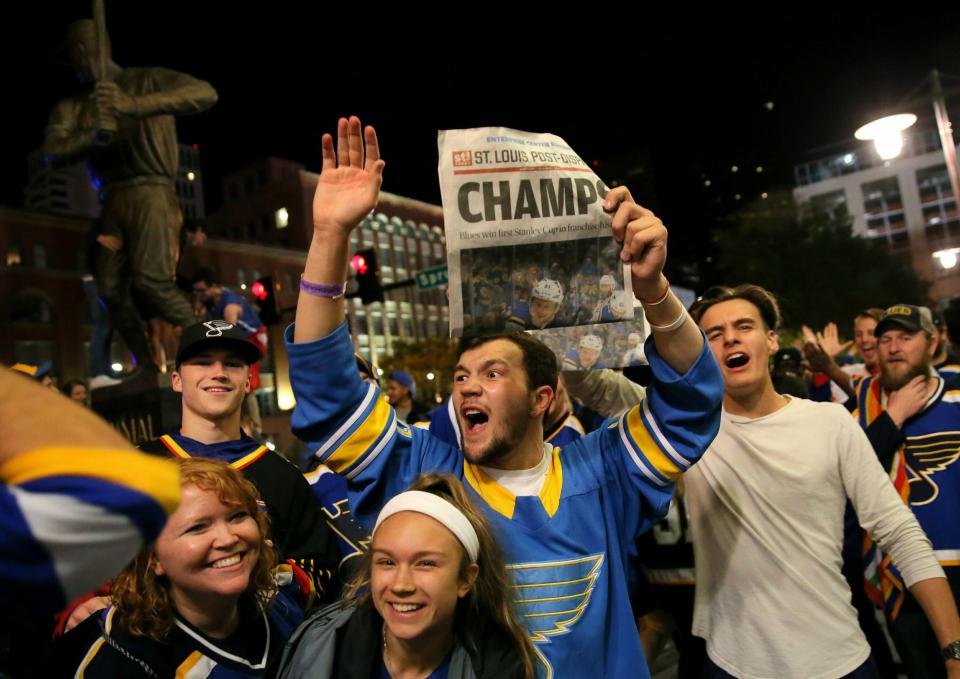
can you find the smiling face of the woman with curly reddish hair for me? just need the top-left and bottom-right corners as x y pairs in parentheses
(153, 483), (261, 610)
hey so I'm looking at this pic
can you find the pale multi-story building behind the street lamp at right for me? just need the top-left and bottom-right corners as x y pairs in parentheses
(793, 130), (960, 304)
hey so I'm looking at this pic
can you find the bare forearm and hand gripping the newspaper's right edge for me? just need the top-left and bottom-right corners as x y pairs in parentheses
(603, 186), (703, 374)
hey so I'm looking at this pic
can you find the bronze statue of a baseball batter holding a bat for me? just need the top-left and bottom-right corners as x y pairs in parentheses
(43, 11), (217, 372)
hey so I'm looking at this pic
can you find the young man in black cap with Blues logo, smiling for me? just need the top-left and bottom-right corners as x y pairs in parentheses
(140, 320), (340, 600)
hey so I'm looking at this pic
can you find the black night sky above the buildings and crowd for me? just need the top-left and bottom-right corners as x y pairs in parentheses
(0, 0), (960, 248)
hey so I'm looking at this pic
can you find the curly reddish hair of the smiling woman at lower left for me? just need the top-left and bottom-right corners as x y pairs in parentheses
(110, 457), (277, 641)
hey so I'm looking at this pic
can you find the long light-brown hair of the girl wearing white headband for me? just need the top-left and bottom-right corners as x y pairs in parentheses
(344, 472), (534, 679)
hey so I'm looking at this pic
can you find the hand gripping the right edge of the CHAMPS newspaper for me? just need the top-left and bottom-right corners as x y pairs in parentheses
(603, 186), (667, 298)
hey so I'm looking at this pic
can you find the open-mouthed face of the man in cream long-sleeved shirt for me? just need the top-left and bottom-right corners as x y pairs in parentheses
(700, 299), (780, 397)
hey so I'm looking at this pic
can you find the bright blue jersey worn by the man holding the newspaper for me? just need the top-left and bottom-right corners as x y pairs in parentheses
(287, 324), (723, 677)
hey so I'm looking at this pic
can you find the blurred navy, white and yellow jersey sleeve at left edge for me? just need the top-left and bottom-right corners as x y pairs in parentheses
(0, 446), (180, 622)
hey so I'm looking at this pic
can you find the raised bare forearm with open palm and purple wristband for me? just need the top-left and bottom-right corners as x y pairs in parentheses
(293, 116), (384, 344)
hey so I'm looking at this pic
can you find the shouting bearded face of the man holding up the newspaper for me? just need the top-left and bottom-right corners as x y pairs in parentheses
(453, 339), (536, 464)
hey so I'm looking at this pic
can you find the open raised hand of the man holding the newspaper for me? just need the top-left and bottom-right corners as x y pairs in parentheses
(313, 116), (385, 235)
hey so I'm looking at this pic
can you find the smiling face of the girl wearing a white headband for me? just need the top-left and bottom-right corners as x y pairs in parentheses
(370, 512), (479, 646)
